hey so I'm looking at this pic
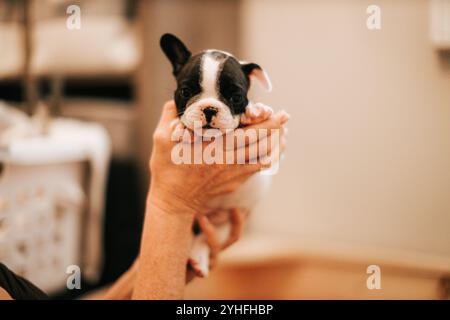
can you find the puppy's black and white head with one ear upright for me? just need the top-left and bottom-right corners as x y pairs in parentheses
(161, 34), (271, 130)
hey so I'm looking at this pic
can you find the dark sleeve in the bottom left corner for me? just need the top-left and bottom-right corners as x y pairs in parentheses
(0, 263), (48, 300)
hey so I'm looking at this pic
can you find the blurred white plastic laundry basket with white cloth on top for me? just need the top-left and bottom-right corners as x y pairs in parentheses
(0, 119), (110, 293)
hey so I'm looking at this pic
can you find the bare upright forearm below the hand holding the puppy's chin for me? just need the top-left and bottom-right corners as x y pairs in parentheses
(133, 190), (194, 299)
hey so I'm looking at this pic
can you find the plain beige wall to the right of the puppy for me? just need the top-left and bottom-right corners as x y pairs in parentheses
(241, 0), (450, 256)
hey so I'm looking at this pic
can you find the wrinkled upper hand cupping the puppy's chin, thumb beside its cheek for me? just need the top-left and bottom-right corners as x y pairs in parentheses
(148, 101), (289, 215)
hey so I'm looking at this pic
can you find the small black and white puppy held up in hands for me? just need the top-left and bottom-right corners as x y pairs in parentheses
(160, 34), (272, 276)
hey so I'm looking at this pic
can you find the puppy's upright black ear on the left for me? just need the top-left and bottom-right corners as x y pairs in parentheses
(160, 33), (191, 76)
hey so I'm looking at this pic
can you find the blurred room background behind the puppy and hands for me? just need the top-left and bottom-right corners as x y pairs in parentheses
(0, 0), (450, 299)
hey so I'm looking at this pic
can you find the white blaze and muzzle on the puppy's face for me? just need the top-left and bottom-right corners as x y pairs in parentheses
(181, 51), (240, 130)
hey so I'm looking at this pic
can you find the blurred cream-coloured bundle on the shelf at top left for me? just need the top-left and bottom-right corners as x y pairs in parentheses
(0, 0), (140, 79)
